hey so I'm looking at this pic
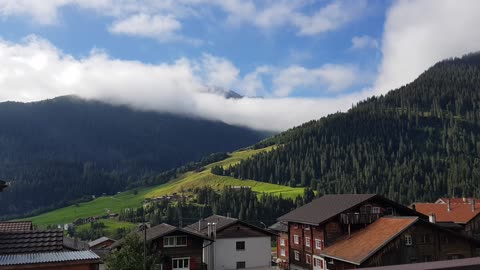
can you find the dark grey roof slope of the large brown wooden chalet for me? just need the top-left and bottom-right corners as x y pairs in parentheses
(277, 194), (376, 225)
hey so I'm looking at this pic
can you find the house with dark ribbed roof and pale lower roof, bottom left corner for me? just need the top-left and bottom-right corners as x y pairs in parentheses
(0, 230), (100, 270)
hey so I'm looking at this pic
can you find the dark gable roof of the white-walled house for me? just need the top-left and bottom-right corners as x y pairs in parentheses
(184, 215), (275, 235)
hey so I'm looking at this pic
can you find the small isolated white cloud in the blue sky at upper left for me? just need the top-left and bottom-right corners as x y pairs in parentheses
(109, 13), (182, 40)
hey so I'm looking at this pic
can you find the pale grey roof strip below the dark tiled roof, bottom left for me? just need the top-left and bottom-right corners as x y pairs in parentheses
(0, 250), (100, 266)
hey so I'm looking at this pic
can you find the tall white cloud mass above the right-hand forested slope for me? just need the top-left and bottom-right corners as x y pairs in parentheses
(375, 0), (480, 94)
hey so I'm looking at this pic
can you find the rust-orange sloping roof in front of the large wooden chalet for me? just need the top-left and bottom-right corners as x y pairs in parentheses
(322, 217), (418, 265)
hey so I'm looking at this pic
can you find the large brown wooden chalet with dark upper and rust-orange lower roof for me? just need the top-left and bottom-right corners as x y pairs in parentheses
(278, 194), (477, 270)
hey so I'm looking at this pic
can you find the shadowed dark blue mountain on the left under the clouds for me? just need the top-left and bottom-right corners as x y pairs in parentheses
(0, 96), (267, 216)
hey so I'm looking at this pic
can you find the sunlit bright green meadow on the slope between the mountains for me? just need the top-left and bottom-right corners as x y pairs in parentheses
(24, 147), (303, 228)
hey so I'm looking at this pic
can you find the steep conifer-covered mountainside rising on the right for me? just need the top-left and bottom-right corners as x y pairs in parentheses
(222, 53), (480, 203)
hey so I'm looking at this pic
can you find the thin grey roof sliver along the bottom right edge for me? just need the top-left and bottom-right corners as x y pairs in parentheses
(362, 257), (480, 270)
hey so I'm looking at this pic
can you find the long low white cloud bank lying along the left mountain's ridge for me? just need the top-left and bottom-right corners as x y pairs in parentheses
(0, 36), (363, 130)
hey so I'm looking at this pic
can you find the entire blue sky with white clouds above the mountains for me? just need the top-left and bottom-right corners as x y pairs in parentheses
(0, 0), (480, 131)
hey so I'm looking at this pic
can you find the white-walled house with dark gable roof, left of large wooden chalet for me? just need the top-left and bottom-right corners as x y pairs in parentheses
(185, 215), (275, 270)
